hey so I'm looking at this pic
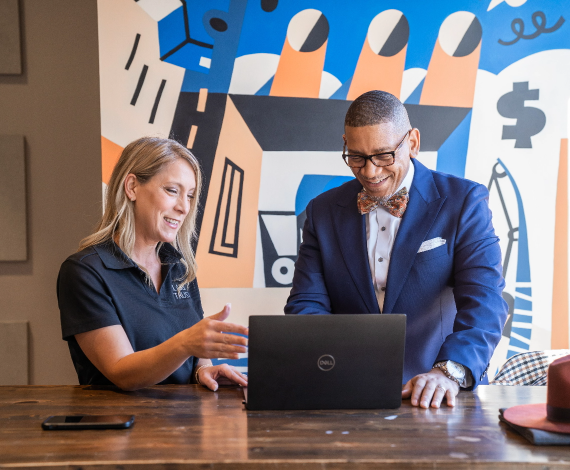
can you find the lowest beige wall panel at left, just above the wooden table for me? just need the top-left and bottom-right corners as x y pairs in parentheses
(0, 321), (29, 385)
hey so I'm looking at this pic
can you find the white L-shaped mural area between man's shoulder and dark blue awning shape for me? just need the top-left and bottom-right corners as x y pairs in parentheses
(259, 151), (353, 211)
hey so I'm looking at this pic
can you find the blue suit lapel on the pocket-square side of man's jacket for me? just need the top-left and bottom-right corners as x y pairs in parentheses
(383, 160), (446, 313)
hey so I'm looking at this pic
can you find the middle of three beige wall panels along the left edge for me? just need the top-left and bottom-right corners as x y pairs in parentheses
(0, 135), (28, 261)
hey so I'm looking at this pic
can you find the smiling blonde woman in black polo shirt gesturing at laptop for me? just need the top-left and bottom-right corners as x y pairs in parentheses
(57, 137), (247, 390)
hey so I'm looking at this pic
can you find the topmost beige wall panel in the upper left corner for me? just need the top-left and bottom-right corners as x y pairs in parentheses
(0, 0), (22, 75)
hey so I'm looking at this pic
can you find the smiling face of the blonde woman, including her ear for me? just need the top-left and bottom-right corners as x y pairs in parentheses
(127, 158), (196, 245)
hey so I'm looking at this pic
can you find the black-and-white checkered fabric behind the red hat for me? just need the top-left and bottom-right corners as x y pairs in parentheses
(489, 349), (570, 385)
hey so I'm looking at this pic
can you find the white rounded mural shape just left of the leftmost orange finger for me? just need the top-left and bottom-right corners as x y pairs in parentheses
(229, 54), (279, 95)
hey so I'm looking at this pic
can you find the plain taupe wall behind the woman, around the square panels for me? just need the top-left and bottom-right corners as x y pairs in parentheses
(0, 0), (101, 384)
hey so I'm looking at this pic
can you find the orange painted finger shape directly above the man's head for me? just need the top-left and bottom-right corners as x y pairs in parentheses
(346, 38), (408, 100)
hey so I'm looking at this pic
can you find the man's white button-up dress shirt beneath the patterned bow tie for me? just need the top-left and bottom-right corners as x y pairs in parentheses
(366, 162), (414, 311)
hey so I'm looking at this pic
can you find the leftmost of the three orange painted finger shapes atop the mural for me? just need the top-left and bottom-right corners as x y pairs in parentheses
(269, 38), (328, 98)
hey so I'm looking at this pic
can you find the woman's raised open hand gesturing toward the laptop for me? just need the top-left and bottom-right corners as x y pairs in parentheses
(184, 304), (248, 359)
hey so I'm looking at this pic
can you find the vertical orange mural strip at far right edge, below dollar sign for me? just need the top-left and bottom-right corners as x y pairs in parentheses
(550, 139), (569, 349)
